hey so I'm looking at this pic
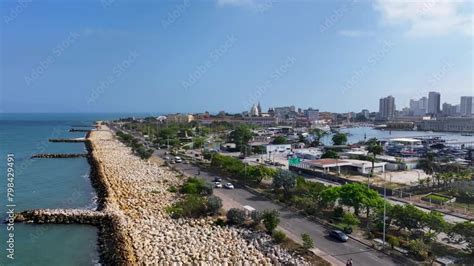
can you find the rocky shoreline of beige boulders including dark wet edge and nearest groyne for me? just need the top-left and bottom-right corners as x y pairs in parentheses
(13, 125), (314, 265)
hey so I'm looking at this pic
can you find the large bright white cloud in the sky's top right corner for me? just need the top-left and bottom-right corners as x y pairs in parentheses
(374, 0), (474, 36)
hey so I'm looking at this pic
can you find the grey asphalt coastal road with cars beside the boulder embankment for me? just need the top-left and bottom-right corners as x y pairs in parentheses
(172, 162), (400, 266)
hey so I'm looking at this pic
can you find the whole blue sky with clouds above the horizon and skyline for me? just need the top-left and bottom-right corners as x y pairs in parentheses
(0, 0), (474, 113)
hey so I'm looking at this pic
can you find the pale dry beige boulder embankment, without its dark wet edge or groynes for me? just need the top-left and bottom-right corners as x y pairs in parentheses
(89, 128), (312, 265)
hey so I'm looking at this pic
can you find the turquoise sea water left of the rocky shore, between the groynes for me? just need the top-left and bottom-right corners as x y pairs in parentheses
(0, 114), (148, 265)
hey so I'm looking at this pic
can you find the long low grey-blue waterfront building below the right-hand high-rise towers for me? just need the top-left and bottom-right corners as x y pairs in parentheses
(417, 117), (474, 133)
